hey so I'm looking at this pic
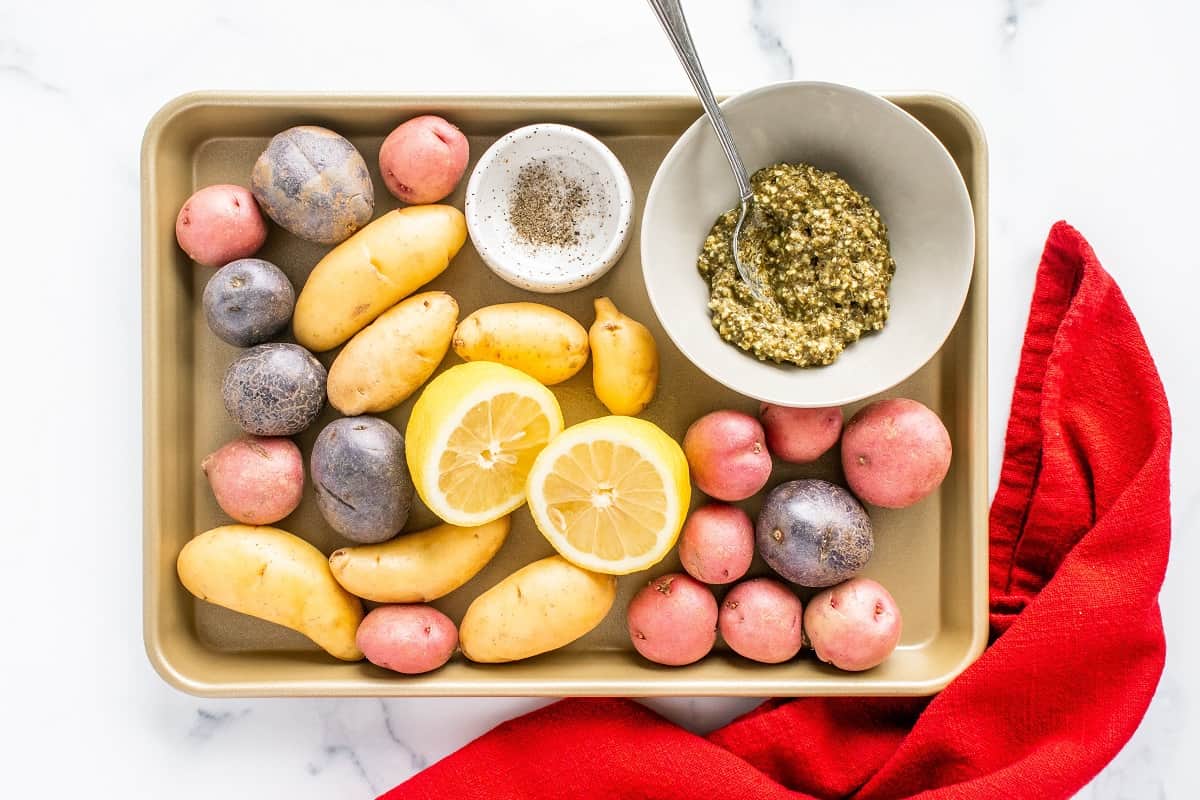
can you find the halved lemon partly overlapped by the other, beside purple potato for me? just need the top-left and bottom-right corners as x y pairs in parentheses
(404, 361), (563, 527)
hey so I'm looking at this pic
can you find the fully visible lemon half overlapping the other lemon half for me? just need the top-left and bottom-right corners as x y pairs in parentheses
(527, 416), (691, 575)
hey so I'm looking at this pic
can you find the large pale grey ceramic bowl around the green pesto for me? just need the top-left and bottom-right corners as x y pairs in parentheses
(642, 82), (974, 408)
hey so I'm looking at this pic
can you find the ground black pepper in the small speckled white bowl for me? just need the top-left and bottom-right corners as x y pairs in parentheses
(509, 161), (590, 247)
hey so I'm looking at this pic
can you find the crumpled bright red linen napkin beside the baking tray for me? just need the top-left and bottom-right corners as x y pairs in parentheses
(383, 222), (1171, 800)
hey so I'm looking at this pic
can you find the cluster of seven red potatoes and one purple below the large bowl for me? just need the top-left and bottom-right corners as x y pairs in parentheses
(628, 398), (952, 670)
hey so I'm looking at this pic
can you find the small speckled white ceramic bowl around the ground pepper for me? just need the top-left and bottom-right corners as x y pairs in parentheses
(466, 124), (634, 293)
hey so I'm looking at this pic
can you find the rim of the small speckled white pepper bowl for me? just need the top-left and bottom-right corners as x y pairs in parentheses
(463, 122), (634, 294)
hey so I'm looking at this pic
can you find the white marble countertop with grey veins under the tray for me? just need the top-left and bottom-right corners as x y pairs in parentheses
(0, 0), (1200, 800)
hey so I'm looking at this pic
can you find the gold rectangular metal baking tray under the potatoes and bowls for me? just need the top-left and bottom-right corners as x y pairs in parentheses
(142, 92), (988, 697)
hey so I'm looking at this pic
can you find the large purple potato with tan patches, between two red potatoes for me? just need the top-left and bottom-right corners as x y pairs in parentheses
(251, 125), (374, 245)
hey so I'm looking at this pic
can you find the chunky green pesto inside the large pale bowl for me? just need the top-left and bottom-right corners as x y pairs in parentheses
(697, 163), (895, 367)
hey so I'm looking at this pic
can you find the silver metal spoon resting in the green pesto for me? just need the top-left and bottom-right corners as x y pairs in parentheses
(649, 0), (769, 302)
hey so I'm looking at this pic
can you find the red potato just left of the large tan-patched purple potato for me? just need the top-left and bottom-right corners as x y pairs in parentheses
(175, 184), (266, 266)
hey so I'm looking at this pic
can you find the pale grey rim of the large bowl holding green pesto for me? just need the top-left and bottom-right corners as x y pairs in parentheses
(638, 80), (977, 408)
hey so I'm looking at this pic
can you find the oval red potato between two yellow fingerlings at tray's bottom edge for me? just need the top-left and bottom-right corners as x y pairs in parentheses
(355, 606), (458, 675)
